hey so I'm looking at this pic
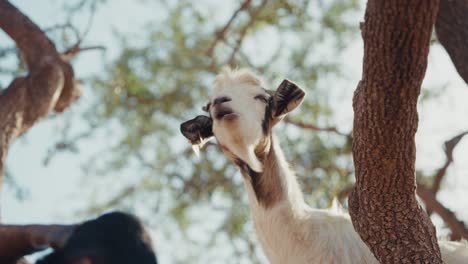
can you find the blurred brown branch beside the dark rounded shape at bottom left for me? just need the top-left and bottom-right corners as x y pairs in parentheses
(0, 224), (76, 256)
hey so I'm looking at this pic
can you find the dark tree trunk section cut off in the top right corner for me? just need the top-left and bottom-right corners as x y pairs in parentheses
(435, 0), (468, 83)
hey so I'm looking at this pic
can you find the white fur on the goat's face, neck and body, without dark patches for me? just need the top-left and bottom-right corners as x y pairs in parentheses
(208, 68), (468, 264)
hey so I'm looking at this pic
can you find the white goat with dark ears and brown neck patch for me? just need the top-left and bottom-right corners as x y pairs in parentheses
(181, 69), (468, 264)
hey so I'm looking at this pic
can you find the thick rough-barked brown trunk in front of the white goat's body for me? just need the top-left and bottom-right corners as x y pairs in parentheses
(349, 0), (442, 263)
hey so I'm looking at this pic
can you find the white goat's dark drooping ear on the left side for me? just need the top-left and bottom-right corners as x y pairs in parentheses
(180, 115), (213, 145)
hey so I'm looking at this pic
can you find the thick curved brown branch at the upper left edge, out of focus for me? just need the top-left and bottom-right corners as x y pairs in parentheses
(0, 0), (81, 262)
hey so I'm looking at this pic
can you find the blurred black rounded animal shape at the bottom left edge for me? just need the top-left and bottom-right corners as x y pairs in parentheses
(36, 212), (157, 264)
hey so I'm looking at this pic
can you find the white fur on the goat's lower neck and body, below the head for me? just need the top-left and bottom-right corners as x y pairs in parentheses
(245, 139), (468, 264)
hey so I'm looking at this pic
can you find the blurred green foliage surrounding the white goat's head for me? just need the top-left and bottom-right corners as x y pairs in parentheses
(77, 0), (358, 260)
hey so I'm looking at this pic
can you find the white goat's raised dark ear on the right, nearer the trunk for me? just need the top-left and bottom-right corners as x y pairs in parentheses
(272, 80), (305, 118)
